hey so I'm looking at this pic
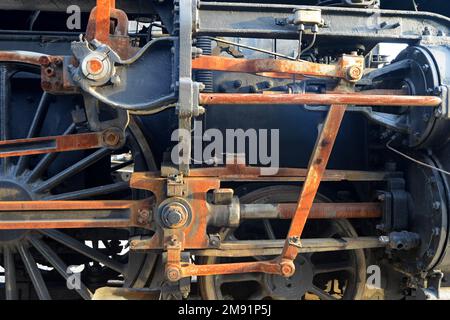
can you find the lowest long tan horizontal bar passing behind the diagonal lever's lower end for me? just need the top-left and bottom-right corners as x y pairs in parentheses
(192, 237), (387, 257)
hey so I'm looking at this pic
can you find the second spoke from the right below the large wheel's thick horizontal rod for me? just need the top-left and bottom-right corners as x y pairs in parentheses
(27, 235), (92, 300)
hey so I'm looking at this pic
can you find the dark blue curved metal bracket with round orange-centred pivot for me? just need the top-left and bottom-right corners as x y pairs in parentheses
(69, 37), (177, 114)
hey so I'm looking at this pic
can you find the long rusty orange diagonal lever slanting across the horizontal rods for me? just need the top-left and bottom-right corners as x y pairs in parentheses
(282, 105), (346, 261)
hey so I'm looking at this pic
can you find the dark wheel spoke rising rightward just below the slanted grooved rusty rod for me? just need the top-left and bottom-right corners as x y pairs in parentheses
(33, 148), (111, 193)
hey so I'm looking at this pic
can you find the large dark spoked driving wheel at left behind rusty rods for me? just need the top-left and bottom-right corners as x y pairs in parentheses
(0, 64), (156, 300)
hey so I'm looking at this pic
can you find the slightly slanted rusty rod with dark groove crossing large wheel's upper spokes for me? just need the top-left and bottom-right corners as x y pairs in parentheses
(0, 132), (107, 158)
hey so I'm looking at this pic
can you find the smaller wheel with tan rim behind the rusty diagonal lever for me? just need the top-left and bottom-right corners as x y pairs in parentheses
(199, 186), (366, 300)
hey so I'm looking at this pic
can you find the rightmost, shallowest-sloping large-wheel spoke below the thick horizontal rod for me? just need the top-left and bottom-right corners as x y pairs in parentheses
(40, 230), (125, 274)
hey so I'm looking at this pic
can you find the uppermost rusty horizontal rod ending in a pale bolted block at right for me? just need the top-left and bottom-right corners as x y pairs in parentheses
(192, 55), (364, 81)
